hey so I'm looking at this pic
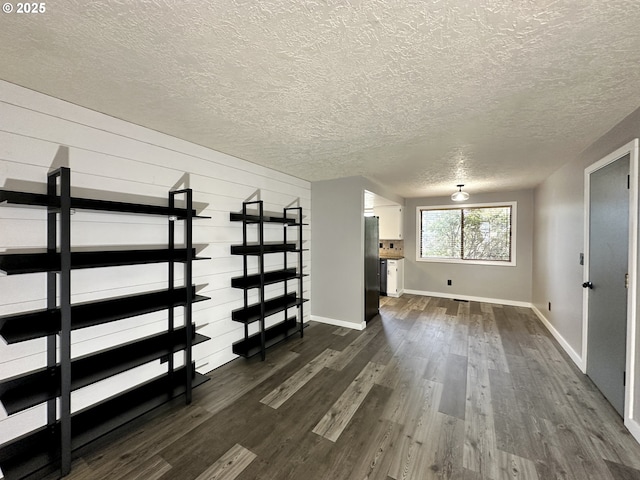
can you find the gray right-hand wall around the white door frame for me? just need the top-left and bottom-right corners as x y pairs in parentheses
(533, 109), (640, 390)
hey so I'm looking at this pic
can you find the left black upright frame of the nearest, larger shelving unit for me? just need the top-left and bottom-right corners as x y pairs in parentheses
(47, 167), (71, 476)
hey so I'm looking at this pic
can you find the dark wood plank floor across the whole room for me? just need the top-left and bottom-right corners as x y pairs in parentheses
(53, 295), (640, 480)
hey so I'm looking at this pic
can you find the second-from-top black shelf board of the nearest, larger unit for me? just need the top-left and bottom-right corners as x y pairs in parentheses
(0, 248), (202, 275)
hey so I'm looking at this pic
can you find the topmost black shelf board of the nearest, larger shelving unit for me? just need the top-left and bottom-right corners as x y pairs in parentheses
(0, 190), (198, 218)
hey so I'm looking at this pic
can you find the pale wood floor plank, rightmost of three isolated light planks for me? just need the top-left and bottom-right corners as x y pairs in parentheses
(313, 363), (384, 442)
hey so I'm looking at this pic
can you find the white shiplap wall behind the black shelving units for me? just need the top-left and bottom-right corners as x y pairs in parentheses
(0, 81), (311, 443)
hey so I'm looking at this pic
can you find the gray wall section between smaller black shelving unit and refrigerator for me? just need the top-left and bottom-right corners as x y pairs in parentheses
(311, 177), (403, 328)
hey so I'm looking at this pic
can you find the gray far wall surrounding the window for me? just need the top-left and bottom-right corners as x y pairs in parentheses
(404, 190), (533, 304)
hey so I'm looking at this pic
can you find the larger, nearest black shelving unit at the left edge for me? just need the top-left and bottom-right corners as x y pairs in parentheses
(0, 168), (208, 480)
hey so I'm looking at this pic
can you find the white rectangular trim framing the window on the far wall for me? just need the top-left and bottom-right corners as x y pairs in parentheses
(416, 202), (518, 267)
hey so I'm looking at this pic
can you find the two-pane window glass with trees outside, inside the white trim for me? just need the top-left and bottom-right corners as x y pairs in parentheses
(417, 202), (516, 265)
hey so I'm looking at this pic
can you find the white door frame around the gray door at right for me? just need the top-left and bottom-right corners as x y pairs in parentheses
(581, 138), (640, 428)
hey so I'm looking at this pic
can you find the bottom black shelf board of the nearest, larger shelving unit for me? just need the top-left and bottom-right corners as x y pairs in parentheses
(0, 364), (209, 480)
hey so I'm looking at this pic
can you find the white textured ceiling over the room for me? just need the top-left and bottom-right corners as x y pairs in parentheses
(0, 0), (640, 197)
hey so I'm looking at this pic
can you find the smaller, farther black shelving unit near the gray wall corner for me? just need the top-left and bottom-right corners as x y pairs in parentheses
(230, 200), (307, 360)
